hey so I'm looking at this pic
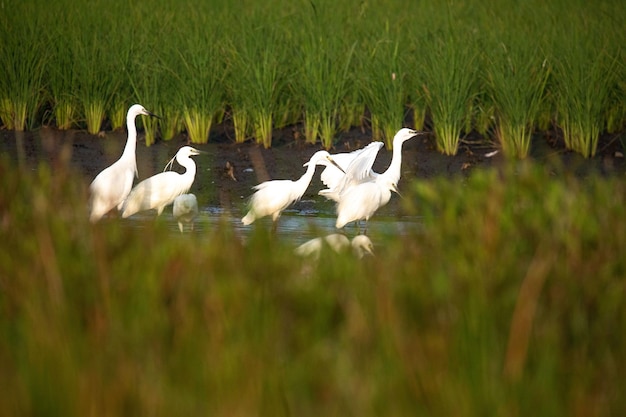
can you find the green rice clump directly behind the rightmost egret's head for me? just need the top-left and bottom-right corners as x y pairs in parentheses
(364, 36), (408, 149)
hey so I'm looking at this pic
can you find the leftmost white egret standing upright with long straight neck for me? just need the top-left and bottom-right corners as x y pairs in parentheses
(89, 104), (158, 222)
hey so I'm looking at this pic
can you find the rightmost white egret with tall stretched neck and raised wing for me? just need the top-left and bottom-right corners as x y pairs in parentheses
(332, 128), (419, 229)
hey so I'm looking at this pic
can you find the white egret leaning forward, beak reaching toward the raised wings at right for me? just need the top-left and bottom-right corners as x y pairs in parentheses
(241, 151), (341, 227)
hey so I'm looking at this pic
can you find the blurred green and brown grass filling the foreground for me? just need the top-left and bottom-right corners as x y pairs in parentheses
(0, 158), (626, 416)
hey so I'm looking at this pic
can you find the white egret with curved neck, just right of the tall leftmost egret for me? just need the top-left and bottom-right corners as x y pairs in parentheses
(122, 146), (201, 218)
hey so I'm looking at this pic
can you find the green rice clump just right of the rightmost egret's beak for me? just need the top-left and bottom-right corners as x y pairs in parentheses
(421, 29), (477, 155)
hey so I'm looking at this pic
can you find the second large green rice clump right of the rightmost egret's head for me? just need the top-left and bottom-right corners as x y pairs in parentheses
(486, 36), (550, 159)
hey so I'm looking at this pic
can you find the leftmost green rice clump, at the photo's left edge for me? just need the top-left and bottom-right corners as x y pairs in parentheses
(0, 2), (49, 131)
